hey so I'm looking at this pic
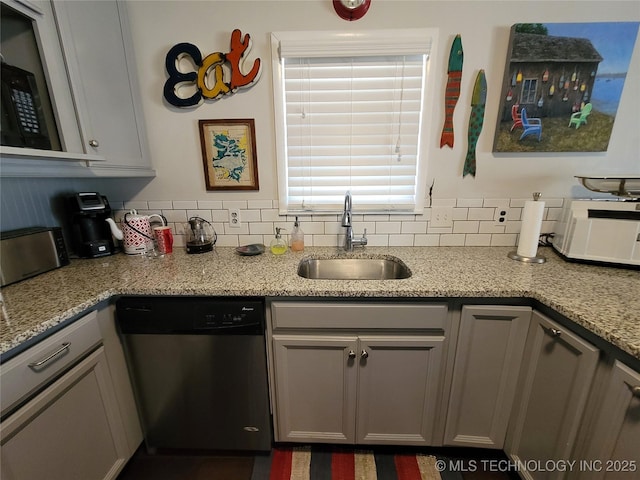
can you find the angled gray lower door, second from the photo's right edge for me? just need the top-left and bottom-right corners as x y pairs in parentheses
(505, 312), (598, 479)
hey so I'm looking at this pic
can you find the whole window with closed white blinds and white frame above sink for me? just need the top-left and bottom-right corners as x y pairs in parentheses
(272, 29), (435, 214)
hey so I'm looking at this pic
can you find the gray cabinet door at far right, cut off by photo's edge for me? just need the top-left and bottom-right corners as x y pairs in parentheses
(580, 360), (640, 479)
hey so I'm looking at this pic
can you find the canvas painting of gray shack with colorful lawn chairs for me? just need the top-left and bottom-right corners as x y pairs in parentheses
(493, 22), (639, 152)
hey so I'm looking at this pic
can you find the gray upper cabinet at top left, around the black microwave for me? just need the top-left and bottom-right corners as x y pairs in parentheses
(1, 0), (155, 177)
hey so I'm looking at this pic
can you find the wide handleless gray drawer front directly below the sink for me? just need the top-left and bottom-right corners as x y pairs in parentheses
(271, 301), (448, 330)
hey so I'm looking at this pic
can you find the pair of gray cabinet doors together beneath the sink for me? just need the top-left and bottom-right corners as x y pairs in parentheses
(273, 335), (444, 445)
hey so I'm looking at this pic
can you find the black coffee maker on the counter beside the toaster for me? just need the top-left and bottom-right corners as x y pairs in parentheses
(67, 192), (116, 258)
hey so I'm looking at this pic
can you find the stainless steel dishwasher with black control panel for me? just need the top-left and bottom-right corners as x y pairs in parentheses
(116, 297), (272, 453)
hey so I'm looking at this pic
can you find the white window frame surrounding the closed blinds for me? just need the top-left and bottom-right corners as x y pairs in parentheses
(271, 28), (438, 215)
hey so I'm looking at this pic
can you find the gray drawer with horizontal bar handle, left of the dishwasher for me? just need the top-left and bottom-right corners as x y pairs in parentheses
(0, 310), (101, 417)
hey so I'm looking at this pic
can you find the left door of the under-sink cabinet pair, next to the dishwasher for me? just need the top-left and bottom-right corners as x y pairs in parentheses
(273, 335), (357, 443)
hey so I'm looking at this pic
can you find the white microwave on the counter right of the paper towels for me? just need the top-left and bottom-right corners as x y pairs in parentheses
(553, 199), (640, 267)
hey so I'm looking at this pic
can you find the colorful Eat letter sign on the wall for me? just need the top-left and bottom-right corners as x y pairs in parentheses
(164, 29), (262, 107)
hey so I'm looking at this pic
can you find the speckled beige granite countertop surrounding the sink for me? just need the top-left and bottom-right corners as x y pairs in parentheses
(0, 247), (640, 359)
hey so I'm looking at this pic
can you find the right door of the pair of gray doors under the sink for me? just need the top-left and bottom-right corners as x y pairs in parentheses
(357, 335), (444, 445)
